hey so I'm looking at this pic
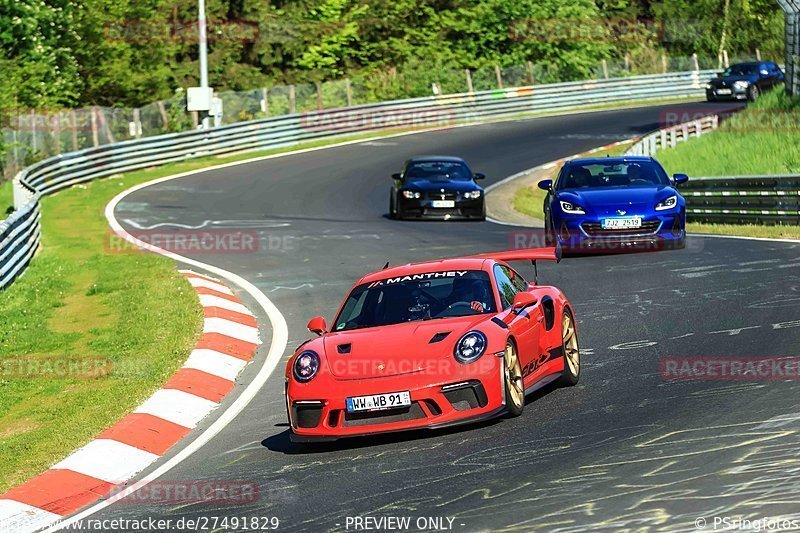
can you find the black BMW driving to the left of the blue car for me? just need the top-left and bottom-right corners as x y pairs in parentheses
(389, 156), (486, 220)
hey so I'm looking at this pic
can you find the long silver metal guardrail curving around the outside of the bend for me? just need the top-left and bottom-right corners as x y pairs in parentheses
(0, 70), (715, 289)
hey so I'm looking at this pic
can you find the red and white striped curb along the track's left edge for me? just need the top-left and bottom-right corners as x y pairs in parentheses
(0, 270), (261, 533)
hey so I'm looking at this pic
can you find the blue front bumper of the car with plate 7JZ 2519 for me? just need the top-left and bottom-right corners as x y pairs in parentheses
(553, 211), (686, 253)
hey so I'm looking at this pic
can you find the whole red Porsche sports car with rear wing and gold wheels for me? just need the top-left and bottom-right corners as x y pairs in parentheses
(286, 248), (580, 442)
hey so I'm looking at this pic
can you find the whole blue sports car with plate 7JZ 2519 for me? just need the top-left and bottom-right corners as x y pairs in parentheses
(539, 157), (689, 252)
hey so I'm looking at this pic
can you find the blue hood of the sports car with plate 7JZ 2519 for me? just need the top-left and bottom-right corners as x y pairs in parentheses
(557, 185), (677, 215)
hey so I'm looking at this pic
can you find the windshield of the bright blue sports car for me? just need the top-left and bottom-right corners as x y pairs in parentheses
(556, 161), (670, 191)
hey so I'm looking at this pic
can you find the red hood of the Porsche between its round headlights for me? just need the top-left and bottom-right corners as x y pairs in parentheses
(322, 314), (494, 379)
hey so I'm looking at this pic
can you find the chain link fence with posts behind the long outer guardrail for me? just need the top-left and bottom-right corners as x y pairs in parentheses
(0, 51), (780, 179)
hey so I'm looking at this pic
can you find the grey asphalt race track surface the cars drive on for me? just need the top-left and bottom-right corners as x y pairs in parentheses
(95, 105), (800, 531)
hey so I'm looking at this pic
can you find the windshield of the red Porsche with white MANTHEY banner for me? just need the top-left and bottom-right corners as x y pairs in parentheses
(334, 270), (495, 331)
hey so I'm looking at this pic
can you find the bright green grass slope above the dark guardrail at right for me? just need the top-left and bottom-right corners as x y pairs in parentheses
(656, 90), (800, 176)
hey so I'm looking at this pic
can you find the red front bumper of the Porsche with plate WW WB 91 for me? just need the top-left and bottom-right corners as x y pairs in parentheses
(286, 354), (505, 442)
